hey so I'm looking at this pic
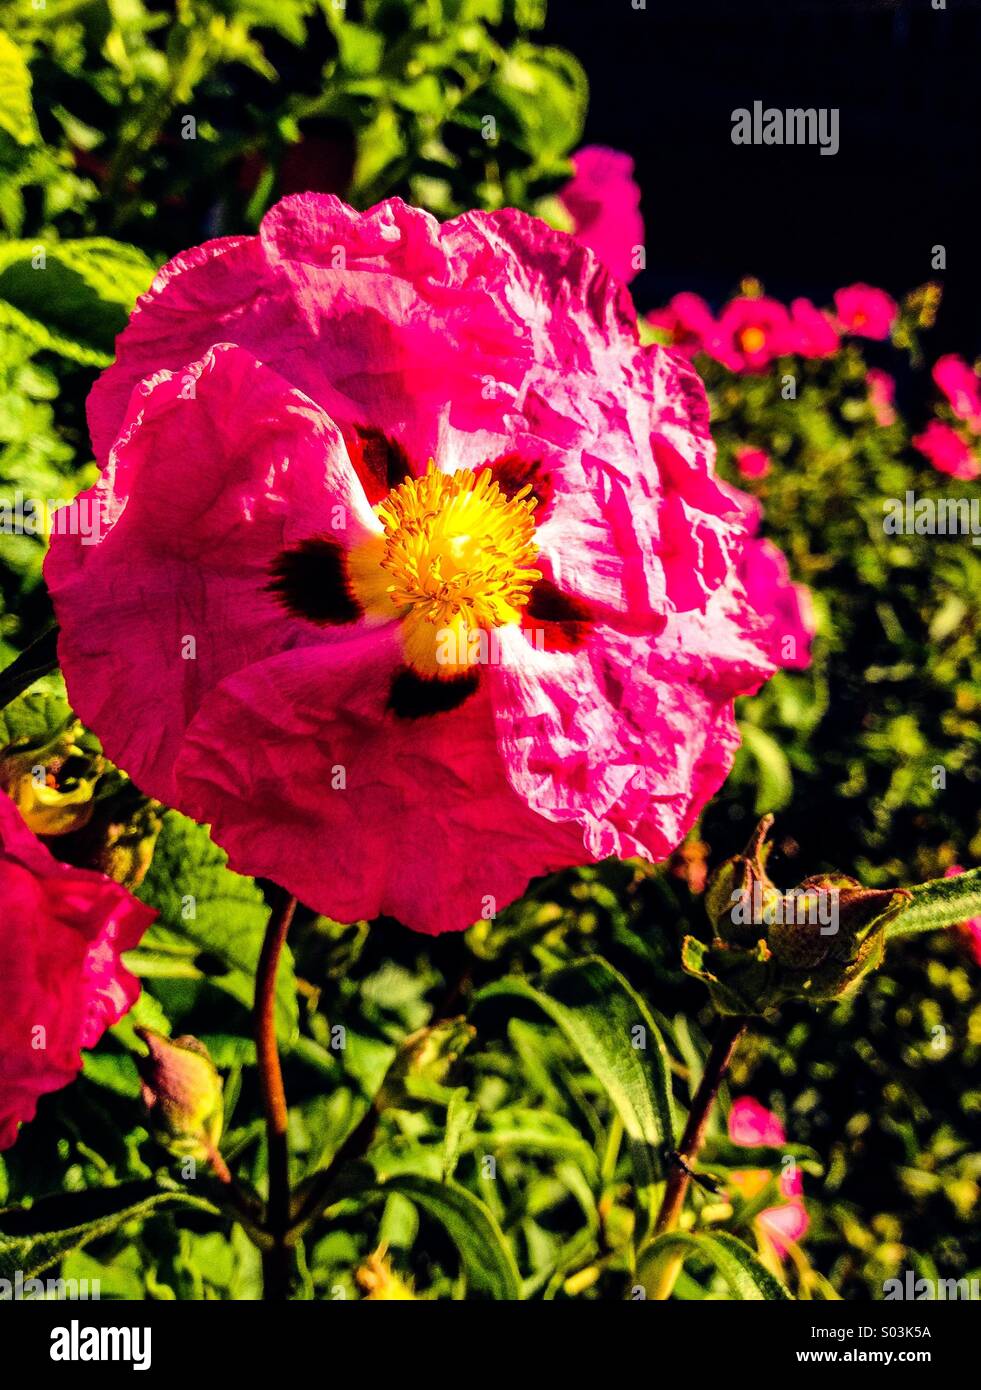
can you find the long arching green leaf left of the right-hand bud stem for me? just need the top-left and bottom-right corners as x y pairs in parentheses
(477, 956), (674, 1211)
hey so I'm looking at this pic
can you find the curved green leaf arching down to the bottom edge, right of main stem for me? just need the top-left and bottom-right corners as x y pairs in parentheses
(381, 1173), (521, 1301)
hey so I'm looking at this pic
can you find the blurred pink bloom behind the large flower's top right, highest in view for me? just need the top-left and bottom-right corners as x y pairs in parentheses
(559, 145), (643, 285)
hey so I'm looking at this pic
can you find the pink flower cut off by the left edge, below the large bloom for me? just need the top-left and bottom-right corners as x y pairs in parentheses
(0, 792), (156, 1150)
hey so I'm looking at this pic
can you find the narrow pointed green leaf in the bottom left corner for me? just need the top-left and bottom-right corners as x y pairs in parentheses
(0, 1183), (218, 1280)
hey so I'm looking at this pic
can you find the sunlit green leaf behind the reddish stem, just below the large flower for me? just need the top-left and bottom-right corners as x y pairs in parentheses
(128, 810), (297, 1047)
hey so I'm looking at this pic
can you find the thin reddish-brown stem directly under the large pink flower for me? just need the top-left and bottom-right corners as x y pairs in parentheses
(253, 892), (296, 1301)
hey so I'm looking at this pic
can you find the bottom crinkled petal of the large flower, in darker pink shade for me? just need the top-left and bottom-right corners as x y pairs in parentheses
(178, 631), (588, 934)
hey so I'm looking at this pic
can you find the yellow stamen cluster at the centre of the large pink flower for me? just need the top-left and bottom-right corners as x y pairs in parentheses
(347, 461), (542, 680)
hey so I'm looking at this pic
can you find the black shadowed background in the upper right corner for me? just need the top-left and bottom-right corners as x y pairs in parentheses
(546, 0), (981, 356)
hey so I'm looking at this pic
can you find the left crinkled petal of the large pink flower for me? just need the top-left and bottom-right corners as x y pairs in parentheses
(44, 345), (377, 805)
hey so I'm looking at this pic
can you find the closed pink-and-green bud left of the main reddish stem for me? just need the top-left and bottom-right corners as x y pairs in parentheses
(136, 1029), (222, 1163)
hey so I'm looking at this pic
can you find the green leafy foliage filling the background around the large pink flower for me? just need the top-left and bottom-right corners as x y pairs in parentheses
(0, 0), (981, 1300)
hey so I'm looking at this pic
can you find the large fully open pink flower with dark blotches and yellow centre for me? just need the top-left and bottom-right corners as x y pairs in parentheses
(46, 195), (805, 933)
